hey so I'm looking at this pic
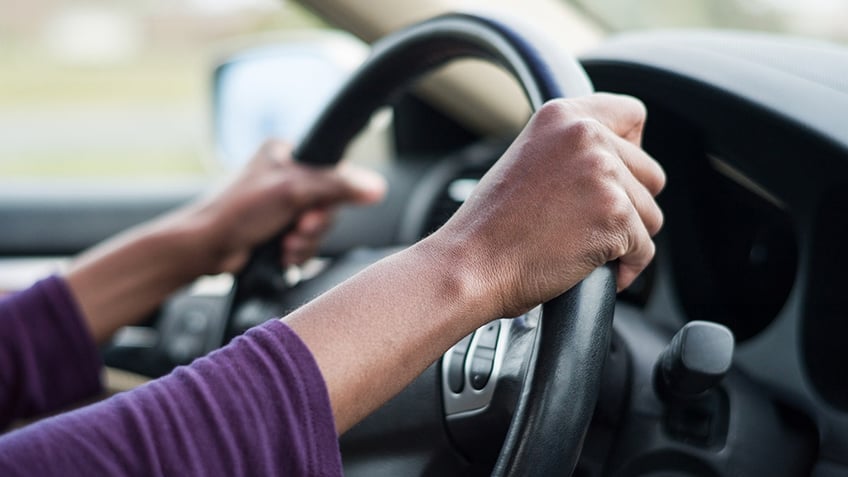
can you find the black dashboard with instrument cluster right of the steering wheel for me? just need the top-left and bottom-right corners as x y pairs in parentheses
(584, 33), (848, 475)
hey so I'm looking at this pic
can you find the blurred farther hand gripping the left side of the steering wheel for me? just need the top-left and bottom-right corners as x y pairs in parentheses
(185, 140), (386, 273)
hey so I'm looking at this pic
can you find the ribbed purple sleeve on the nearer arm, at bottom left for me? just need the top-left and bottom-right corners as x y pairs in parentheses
(0, 320), (342, 476)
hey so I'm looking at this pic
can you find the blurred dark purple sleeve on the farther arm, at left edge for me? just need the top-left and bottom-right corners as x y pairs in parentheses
(0, 276), (101, 430)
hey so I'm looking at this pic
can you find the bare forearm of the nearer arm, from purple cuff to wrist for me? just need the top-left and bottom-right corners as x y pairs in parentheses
(284, 236), (498, 433)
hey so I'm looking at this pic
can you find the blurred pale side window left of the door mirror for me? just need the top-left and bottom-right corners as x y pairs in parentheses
(0, 0), (326, 181)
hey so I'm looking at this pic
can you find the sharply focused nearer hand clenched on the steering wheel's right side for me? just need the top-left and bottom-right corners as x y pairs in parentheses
(428, 94), (665, 316)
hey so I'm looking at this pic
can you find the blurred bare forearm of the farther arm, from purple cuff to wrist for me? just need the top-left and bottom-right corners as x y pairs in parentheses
(65, 211), (206, 342)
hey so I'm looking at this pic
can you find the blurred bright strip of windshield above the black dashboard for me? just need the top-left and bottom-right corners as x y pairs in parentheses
(567, 0), (848, 42)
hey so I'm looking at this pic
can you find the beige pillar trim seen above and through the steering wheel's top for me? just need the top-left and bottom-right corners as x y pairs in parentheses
(300, 0), (603, 135)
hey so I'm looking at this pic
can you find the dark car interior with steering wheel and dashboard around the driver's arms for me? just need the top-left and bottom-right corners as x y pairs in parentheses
(0, 0), (848, 477)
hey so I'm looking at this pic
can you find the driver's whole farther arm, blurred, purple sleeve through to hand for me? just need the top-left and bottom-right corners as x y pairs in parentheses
(0, 142), (385, 429)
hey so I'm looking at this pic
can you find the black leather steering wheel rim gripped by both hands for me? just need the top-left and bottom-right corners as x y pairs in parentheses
(230, 14), (615, 475)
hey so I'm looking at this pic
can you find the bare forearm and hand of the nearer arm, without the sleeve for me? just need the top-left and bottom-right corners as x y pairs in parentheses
(285, 95), (665, 432)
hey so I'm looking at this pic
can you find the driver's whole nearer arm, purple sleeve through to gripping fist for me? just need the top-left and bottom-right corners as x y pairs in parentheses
(0, 95), (664, 475)
